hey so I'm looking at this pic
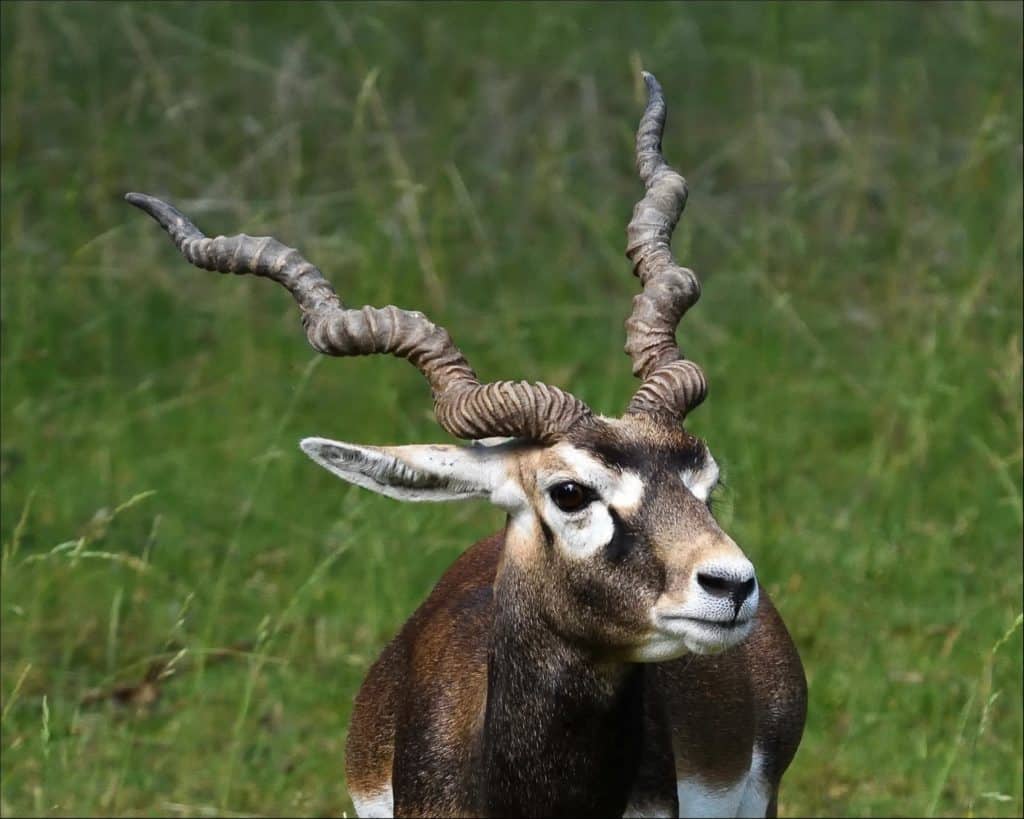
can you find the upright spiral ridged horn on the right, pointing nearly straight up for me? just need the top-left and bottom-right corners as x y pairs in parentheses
(626, 72), (708, 419)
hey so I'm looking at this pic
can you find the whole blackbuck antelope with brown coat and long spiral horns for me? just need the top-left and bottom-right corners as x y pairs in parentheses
(127, 74), (806, 816)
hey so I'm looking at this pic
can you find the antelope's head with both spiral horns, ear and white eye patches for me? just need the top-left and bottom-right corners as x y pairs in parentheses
(126, 73), (758, 661)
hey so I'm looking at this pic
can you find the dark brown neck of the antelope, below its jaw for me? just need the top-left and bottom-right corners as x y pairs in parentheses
(481, 566), (643, 816)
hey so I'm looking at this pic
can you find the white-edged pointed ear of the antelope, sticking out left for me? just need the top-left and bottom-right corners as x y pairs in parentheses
(300, 438), (505, 501)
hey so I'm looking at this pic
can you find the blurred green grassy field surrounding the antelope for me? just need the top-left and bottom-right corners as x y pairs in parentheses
(0, 3), (1024, 816)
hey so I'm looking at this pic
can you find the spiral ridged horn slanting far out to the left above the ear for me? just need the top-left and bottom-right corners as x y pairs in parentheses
(125, 193), (591, 442)
